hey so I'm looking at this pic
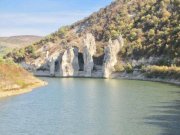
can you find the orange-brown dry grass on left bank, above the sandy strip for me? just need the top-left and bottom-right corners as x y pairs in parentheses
(0, 60), (39, 90)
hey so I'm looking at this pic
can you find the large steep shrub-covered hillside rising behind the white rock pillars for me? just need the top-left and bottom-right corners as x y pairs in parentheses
(7, 0), (180, 80)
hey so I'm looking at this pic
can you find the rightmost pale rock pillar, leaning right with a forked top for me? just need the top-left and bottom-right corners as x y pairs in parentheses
(103, 36), (124, 78)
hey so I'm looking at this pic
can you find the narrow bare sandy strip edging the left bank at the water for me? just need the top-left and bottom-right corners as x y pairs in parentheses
(0, 81), (47, 98)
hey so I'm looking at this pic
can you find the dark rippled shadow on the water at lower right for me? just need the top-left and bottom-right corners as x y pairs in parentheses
(145, 92), (180, 135)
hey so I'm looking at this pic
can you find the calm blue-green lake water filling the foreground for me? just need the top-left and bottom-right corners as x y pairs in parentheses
(0, 78), (180, 135)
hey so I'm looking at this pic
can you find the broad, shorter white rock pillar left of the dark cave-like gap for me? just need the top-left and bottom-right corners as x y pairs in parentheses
(60, 47), (79, 77)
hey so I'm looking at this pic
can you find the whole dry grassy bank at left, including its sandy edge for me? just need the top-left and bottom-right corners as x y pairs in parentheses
(0, 59), (44, 97)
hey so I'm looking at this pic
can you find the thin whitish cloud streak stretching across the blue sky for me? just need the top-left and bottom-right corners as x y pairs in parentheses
(0, 12), (90, 25)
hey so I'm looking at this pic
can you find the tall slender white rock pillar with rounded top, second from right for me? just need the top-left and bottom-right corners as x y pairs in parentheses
(83, 33), (96, 77)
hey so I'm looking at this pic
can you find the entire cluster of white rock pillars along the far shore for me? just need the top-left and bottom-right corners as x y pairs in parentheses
(28, 33), (124, 78)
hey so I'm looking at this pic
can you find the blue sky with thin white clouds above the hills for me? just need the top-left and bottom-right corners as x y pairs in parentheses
(0, 0), (112, 37)
